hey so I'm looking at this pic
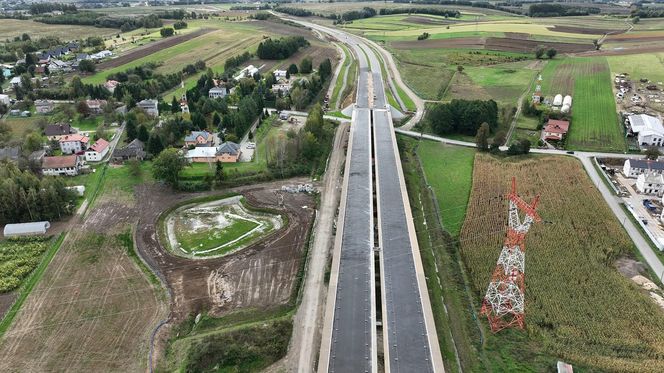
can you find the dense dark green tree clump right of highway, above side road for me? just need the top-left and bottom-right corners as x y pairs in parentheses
(424, 100), (498, 136)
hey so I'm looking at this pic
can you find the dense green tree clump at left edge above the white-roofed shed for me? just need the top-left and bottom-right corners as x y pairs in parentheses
(0, 163), (76, 224)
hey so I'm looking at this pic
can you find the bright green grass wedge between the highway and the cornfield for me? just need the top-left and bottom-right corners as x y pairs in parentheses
(417, 141), (475, 237)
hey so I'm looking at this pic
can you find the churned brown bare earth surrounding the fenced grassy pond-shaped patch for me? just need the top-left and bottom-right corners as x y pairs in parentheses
(136, 180), (314, 366)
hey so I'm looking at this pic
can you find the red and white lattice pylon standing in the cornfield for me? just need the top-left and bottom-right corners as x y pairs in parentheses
(481, 178), (541, 333)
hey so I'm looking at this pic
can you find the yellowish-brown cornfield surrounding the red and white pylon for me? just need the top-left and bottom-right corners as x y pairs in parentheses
(460, 154), (664, 372)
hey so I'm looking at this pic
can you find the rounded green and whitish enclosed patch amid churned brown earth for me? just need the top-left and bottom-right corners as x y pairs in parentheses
(164, 196), (283, 257)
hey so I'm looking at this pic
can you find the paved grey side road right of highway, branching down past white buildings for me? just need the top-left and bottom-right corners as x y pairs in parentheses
(395, 129), (664, 284)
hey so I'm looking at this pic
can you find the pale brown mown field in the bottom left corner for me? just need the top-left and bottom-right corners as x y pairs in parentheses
(0, 201), (166, 372)
